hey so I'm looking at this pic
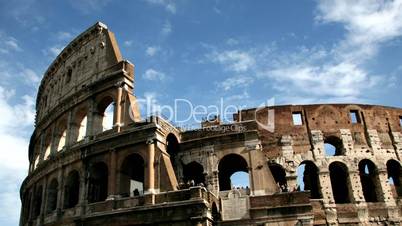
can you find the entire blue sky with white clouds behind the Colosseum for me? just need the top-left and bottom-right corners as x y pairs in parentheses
(0, 0), (402, 225)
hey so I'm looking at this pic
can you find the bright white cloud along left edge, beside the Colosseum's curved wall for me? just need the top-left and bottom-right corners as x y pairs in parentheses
(0, 86), (35, 224)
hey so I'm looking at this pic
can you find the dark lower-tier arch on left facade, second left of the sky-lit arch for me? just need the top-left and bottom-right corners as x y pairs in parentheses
(64, 170), (80, 208)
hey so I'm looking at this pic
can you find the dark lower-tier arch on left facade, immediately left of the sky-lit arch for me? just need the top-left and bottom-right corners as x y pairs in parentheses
(88, 162), (108, 203)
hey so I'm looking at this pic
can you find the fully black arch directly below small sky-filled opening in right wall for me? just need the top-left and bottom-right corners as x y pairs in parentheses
(329, 162), (352, 203)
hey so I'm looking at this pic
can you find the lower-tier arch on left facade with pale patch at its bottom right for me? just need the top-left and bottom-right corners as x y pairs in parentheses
(120, 154), (145, 196)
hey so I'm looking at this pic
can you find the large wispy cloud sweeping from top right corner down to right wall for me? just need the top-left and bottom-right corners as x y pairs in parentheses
(207, 0), (402, 102)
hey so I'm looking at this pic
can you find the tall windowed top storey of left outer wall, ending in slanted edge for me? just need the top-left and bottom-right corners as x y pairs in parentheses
(36, 22), (123, 124)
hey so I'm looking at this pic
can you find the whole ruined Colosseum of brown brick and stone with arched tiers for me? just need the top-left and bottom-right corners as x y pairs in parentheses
(20, 23), (402, 226)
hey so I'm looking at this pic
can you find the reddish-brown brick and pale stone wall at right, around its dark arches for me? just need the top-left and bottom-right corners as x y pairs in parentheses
(235, 104), (402, 224)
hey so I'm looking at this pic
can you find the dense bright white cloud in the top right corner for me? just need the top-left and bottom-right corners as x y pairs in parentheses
(316, 0), (402, 61)
